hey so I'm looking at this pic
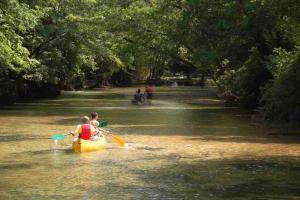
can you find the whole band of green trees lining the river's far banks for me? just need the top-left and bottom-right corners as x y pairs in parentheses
(0, 0), (300, 121)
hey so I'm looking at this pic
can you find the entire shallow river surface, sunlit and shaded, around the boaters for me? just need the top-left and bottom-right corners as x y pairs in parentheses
(0, 87), (300, 199)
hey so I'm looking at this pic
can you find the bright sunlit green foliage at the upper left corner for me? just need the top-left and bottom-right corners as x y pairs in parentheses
(0, 0), (40, 73)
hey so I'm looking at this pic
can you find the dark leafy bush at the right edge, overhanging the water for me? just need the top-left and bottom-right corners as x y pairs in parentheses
(261, 51), (300, 123)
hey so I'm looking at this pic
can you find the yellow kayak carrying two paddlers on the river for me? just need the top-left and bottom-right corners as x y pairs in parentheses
(72, 137), (106, 153)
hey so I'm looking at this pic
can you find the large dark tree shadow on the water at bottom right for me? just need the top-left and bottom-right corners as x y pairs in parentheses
(121, 157), (300, 199)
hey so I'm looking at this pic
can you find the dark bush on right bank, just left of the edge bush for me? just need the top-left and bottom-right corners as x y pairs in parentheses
(217, 48), (273, 109)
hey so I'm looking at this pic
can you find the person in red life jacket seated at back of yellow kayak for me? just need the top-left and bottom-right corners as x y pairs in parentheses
(75, 116), (97, 140)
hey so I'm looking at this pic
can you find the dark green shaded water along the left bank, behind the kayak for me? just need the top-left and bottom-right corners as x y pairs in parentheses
(0, 91), (125, 116)
